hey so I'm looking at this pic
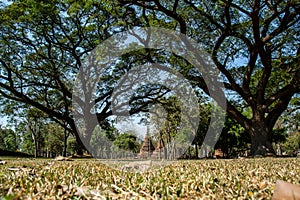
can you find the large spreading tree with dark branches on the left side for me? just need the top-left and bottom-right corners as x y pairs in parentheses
(0, 0), (171, 153)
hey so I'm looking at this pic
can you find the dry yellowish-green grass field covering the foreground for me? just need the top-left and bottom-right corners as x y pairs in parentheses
(0, 158), (300, 199)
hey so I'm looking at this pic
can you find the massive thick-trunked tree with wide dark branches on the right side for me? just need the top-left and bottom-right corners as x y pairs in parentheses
(119, 0), (300, 154)
